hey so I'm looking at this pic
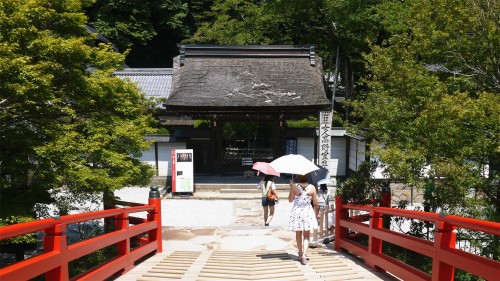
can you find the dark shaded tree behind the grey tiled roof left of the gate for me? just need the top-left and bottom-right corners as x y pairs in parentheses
(87, 0), (188, 67)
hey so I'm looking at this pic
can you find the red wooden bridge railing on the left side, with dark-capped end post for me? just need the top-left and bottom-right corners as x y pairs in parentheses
(0, 187), (162, 281)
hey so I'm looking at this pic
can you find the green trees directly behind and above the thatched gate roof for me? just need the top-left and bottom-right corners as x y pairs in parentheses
(184, 0), (385, 123)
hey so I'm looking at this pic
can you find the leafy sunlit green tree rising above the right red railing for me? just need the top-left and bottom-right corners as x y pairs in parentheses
(353, 0), (500, 217)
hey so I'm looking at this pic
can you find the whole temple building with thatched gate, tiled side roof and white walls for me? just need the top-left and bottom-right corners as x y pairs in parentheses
(115, 45), (364, 177)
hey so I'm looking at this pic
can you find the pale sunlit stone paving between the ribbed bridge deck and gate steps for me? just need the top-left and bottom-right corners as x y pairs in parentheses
(163, 200), (295, 251)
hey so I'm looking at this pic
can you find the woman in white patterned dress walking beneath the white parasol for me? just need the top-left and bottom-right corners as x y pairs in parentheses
(288, 175), (319, 265)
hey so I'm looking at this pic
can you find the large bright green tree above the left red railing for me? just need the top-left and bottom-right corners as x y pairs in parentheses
(0, 0), (152, 221)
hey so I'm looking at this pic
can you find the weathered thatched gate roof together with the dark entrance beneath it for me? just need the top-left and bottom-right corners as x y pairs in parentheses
(163, 45), (331, 176)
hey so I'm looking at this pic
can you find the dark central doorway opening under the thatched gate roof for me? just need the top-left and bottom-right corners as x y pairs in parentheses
(221, 121), (278, 175)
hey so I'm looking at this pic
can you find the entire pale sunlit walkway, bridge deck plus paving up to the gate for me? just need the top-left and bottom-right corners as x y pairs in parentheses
(115, 188), (396, 281)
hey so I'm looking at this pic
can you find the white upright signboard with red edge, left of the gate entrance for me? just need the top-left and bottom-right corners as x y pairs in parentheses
(172, 149), (194, 193)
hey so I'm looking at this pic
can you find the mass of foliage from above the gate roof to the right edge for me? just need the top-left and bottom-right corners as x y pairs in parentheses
(176, 0), (500, 220)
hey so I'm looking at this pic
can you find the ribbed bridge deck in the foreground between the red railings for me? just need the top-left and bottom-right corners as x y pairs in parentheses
(136, 250), (381, 281)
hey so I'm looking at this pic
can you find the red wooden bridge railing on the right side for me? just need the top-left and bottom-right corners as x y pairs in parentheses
(335, 197), (500, 281)
